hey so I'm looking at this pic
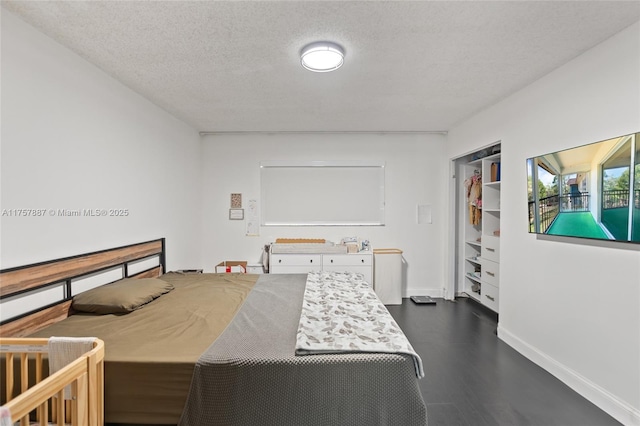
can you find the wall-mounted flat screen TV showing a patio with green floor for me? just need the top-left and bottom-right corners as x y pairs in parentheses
(527, 133), (640, 244)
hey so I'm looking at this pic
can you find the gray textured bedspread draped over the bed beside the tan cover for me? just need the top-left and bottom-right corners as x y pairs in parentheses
(180, 274), (427, 426)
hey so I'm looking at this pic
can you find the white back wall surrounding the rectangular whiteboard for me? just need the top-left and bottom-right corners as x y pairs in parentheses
(202, 134), (447, 295)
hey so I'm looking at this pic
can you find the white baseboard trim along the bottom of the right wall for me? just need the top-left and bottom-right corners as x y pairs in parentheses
(498, 324), (640, 426)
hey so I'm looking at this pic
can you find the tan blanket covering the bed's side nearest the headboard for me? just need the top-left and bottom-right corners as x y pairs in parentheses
(31, 273), (259, 424)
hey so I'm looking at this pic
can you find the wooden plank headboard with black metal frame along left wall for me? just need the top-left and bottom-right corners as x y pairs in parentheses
(0, 238), (166, 337)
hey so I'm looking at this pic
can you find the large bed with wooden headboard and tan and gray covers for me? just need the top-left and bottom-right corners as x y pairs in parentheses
(0, 239), (426, 426)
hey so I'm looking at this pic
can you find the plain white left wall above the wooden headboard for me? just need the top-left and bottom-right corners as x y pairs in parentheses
(0, 10), (200, 268)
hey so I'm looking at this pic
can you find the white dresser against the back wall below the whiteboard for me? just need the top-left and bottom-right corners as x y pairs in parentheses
(269, 251), (373, 285)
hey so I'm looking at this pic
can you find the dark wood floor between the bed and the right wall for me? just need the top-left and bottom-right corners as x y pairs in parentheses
(387, 299), (620, 426)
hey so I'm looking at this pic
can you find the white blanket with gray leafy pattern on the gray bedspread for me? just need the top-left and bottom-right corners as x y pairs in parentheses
(296, 272), (424, 378)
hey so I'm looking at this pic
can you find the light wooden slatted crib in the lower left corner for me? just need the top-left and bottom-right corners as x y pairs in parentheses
(0, 338), (104, 426)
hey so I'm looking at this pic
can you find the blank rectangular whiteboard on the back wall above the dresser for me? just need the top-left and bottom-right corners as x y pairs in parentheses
(260, 161), (384, 226)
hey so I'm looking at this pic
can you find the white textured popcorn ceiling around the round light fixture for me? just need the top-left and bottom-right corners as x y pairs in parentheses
(2, 1), (640, 131)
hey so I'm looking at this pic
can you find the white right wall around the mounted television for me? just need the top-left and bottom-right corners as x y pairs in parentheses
(449, 23), (640, 425)
